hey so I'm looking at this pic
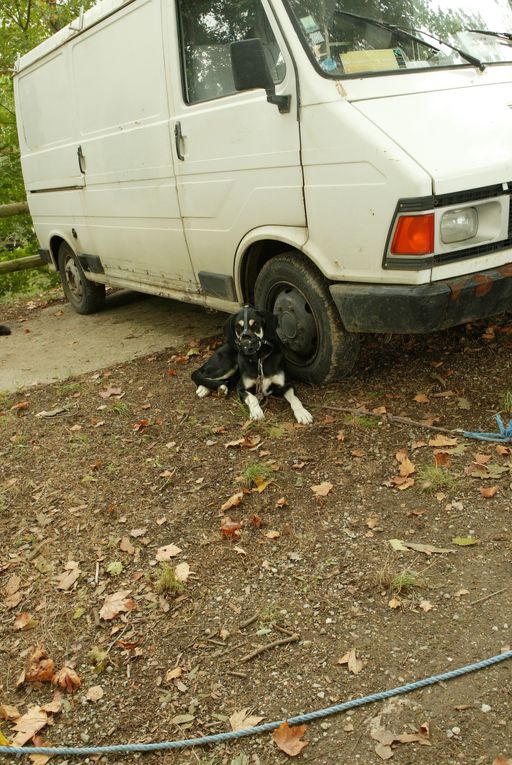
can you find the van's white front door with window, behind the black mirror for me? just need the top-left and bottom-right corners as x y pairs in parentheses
(169, 0), (306, 301)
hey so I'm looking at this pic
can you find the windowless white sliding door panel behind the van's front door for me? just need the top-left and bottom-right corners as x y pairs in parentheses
(72, 0), (198, 294)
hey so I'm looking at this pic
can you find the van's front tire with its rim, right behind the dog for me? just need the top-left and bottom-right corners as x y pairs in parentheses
(254, 253), (360, 383)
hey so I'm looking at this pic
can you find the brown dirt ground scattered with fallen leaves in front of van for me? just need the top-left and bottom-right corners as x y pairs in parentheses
(0, 294), (512, 765)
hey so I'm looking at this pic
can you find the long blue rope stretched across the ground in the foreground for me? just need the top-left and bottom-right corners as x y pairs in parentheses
(0, 651), (512, 756)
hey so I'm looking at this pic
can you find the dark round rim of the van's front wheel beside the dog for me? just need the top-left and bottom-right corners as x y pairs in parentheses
(269, 283), (319, 366)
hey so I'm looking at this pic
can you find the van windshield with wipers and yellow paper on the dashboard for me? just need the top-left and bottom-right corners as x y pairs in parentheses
(287, 0), (512, 77)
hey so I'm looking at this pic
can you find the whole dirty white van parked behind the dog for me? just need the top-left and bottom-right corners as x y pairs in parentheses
(15, 0), (512, 382)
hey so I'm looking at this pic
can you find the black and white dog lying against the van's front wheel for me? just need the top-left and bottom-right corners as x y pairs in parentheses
(192, 305), (313, 425)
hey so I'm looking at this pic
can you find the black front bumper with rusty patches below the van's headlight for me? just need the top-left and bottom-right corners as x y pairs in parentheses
(329, 263), (512, 334)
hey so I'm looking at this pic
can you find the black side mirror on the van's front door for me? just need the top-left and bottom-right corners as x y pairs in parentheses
(230, 37), (291, 113)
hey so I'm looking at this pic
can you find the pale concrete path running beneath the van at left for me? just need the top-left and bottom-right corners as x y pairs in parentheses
(0, 291), (226, 392)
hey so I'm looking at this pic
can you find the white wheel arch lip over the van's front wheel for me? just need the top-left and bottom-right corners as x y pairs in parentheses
(234, 226), (326, 302)
